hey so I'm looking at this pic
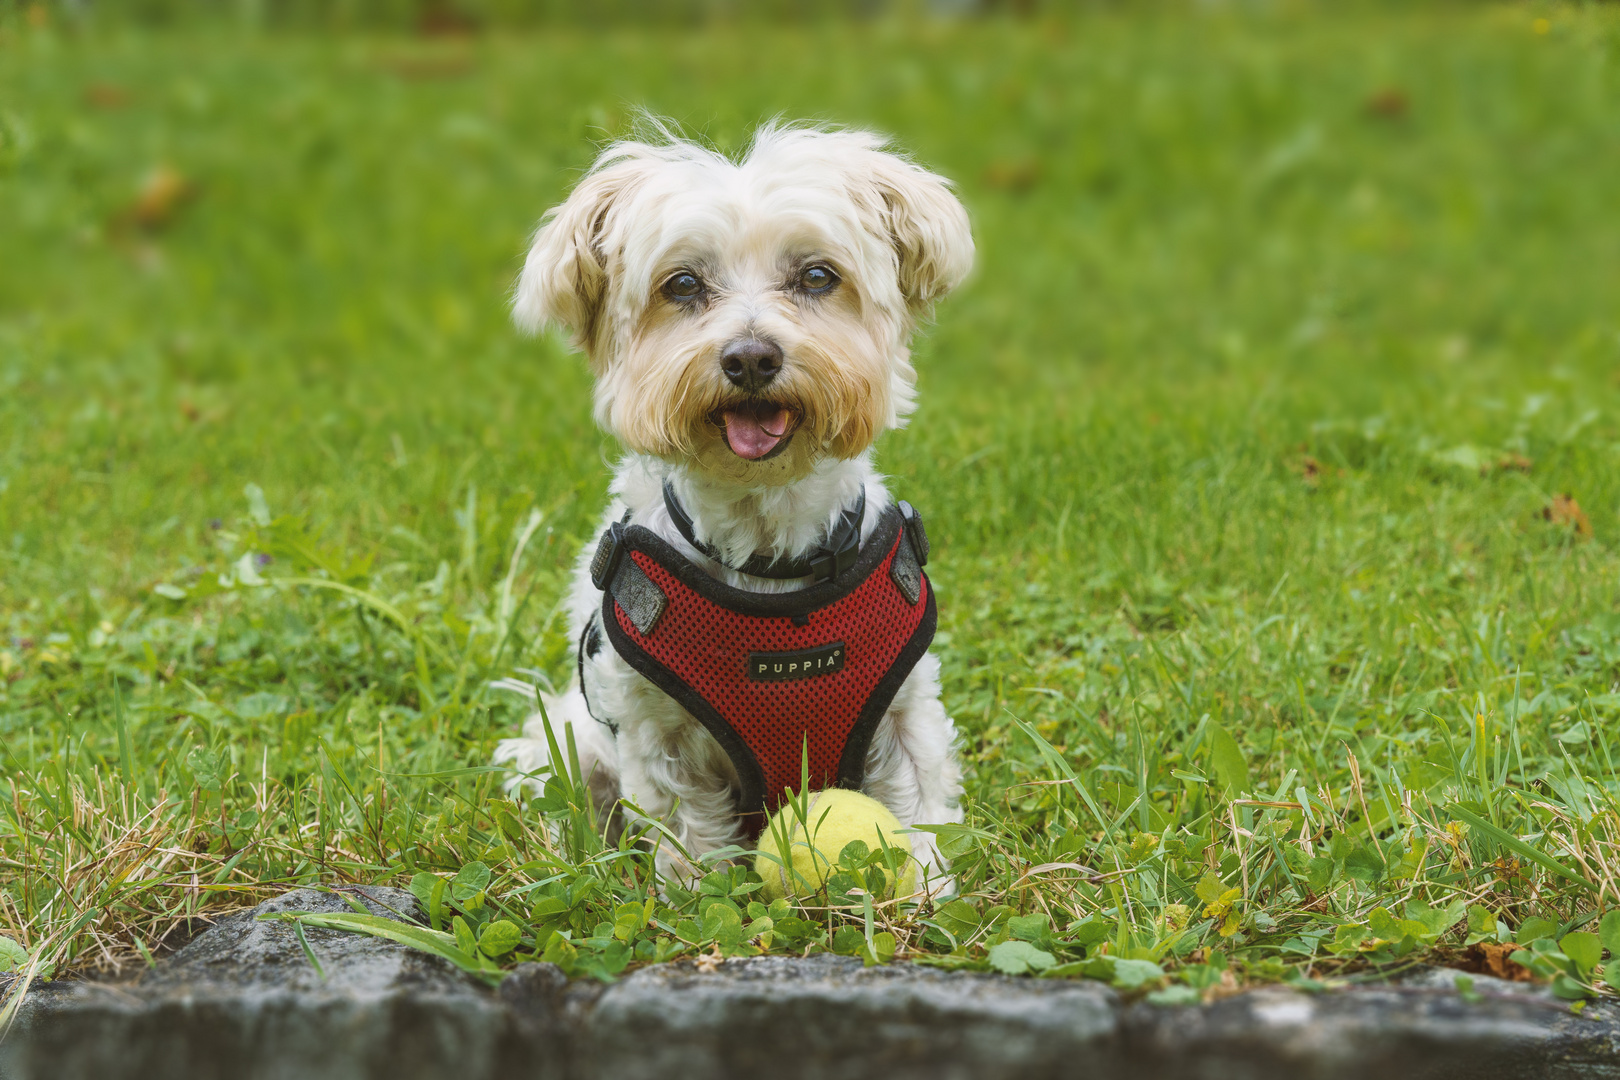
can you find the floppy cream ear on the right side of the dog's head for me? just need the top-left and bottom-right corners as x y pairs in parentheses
(873, 154), (974, 314)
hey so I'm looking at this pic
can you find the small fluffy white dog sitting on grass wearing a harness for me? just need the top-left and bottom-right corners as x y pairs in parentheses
(496, 125), (974, 894)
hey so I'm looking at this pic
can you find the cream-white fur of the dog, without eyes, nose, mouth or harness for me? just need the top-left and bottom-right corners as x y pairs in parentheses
(496, 125), (974, 894)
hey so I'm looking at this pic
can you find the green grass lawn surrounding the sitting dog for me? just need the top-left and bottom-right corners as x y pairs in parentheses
(0, 5), (1620, 999)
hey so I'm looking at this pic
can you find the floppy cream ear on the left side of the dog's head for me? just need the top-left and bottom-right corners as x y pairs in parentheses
(512, 155), (642, 350)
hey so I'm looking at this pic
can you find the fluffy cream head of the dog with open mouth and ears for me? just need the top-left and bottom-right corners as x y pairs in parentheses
(515, 126), (974, 484)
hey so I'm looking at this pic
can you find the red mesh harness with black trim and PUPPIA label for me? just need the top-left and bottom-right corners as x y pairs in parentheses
(591, 502), (935, 824)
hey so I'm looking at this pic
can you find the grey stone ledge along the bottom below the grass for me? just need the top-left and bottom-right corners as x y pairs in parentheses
(0, 889), (1620, 1080)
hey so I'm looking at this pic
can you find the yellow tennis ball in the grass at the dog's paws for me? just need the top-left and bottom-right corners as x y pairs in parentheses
(753, 787), (917, 900)
